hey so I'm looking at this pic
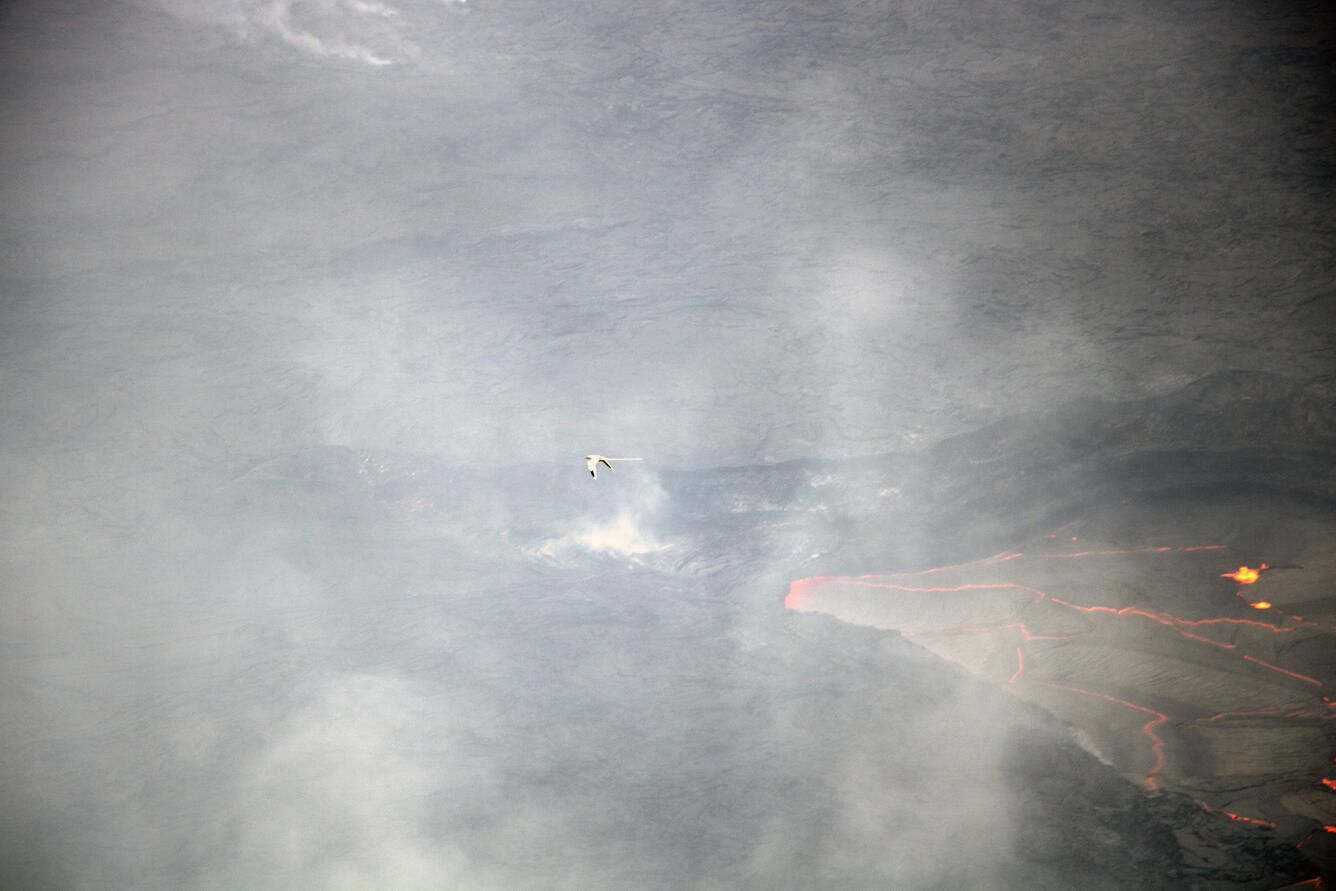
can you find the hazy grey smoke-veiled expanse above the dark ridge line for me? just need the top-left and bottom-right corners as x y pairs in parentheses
(3, 0), (1332, 472)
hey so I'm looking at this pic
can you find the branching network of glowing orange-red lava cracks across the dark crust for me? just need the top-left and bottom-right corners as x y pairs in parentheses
(784, 534), (1336, 832)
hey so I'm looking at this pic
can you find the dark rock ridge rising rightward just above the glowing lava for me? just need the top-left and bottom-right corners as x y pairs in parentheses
(661, 371), (1336, 576)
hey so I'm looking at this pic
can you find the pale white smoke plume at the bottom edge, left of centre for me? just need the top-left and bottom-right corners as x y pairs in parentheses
(228, 675), (468, 888)
